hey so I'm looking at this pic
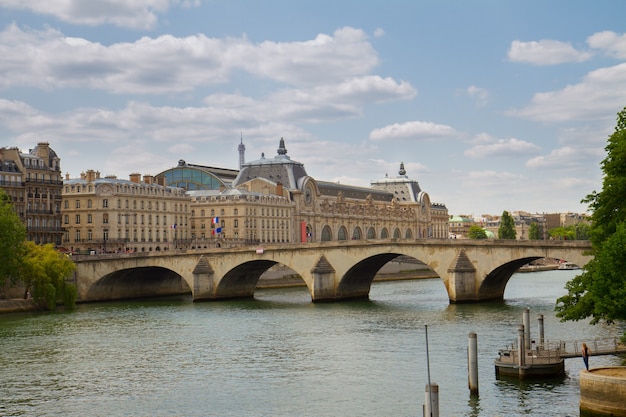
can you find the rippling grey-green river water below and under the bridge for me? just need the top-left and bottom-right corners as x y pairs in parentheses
(0, 271), (623, 417)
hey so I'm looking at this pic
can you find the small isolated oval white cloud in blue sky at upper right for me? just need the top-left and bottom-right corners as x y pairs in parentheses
(508, 39), (593, 65)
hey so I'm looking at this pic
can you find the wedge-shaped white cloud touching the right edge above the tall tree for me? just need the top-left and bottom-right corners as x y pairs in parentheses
(508, 63), (626, 122)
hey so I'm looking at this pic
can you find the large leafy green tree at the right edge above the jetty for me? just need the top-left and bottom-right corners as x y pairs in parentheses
(555, 107), (626, 324)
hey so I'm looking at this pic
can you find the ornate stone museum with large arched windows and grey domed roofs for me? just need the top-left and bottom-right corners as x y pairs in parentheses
(233, 138), (448, 242)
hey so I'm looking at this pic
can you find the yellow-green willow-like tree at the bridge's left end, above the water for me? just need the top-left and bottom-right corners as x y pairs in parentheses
(20, 241), (76, 309)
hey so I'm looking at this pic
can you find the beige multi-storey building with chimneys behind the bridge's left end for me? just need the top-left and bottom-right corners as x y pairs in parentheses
(62, 170), (190, 253)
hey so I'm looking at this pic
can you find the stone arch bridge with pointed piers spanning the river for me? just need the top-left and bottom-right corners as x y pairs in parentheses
(75, 239), (591, 303)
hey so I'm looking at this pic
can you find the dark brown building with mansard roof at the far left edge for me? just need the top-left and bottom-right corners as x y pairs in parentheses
(0, 142), (63, 245)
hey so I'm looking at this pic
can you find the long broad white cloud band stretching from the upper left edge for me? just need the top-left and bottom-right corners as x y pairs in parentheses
(0, 24), (380, 94)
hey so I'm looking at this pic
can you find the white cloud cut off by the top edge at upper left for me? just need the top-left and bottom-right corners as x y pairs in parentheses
(0, 0), (193, 29)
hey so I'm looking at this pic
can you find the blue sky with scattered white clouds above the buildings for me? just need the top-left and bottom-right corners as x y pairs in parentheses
(0, 0), (626, 217)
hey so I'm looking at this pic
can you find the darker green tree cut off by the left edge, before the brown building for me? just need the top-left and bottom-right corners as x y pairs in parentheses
(0, 190), (26, 286)
